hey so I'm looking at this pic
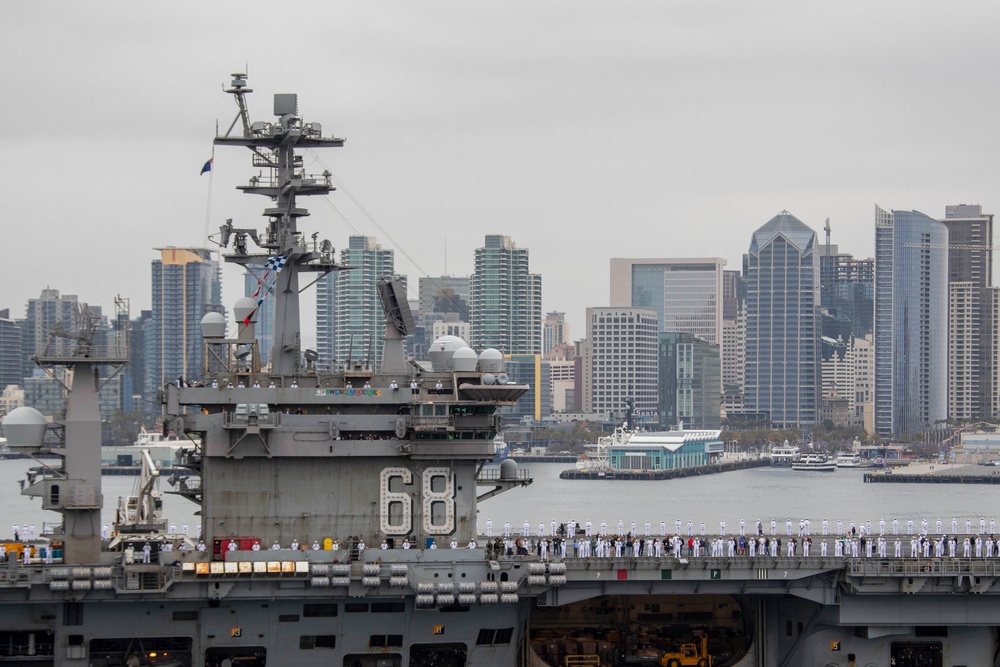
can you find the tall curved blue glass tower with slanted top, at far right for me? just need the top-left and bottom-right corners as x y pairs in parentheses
(875, 206), (948, 437)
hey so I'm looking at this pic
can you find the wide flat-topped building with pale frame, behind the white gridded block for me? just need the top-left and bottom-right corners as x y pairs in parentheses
(611, 257), (726, 344)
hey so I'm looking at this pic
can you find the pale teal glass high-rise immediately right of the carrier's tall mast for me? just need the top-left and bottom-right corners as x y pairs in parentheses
(316, 236), (406, 368)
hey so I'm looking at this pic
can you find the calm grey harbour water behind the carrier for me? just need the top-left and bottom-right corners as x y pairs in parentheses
(0, 460), (1000, 535)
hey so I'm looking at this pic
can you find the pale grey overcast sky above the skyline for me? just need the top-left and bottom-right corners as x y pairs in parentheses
(0, 0), (1000, 340)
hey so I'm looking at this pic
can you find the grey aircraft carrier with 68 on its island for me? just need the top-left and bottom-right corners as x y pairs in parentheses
(0, 74), (1000, 667)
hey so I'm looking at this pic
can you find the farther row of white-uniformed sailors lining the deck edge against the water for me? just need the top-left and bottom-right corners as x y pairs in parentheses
(485, 517), (996, 538)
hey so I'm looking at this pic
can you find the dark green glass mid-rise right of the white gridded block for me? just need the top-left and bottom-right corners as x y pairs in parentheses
(659, 331), (722, 429)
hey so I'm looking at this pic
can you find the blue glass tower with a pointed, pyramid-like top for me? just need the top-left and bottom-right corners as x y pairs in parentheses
(743, 211), (820, 428)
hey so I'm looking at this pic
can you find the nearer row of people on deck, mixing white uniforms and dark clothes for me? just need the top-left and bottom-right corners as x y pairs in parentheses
(488, 535), (1000, 560)
